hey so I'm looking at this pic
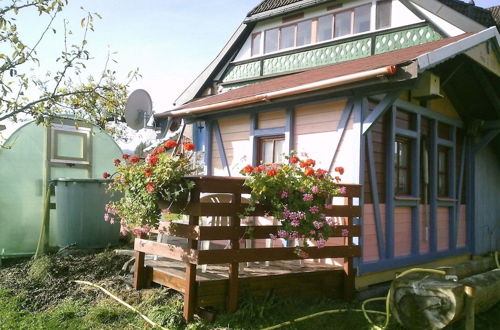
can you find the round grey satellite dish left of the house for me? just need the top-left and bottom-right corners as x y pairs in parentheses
(125, 89), (153, 130)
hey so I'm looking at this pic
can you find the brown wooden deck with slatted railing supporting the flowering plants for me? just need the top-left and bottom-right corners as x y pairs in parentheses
(134, 177), (361, 322)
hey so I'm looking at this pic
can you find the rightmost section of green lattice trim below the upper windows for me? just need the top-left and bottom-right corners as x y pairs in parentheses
(375, 26), (441, 54)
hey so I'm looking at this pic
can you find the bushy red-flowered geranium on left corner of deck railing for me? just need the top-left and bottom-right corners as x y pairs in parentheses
(103, 140), (197, 236)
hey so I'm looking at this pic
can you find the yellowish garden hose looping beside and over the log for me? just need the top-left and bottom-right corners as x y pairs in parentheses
(262, 268), (446, 330)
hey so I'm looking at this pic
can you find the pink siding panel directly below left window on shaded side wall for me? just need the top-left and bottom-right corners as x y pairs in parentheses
(394, 207), (412, 257)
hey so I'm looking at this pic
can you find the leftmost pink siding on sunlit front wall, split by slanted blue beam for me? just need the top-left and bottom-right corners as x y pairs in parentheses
(212, 115), (251, 176)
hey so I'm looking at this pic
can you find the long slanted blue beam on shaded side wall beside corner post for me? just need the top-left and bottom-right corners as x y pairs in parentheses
(366, 132), (385, 259)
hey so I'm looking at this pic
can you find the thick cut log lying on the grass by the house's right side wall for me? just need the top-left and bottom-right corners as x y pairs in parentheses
(390, 269), (500, 329)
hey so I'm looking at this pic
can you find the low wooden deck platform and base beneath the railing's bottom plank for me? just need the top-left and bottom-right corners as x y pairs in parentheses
(145, 258), (344, 310)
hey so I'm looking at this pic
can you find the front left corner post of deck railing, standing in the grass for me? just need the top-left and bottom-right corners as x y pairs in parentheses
(184, 187), (200, 322)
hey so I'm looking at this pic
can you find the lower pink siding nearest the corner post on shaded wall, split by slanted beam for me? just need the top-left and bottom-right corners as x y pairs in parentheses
(361, 204), (385, 261)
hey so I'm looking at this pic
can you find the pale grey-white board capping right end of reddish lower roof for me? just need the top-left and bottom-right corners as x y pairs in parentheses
(417, 26), (500, 72)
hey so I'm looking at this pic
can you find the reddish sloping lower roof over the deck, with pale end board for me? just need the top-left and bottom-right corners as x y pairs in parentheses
(157, 28), (498, 118)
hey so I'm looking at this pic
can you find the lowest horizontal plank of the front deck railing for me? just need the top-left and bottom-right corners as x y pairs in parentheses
(198, 246), (361, 265)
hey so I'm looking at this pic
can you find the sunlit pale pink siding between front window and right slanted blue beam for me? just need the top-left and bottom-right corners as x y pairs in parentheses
(294, 100), (348, 171)
